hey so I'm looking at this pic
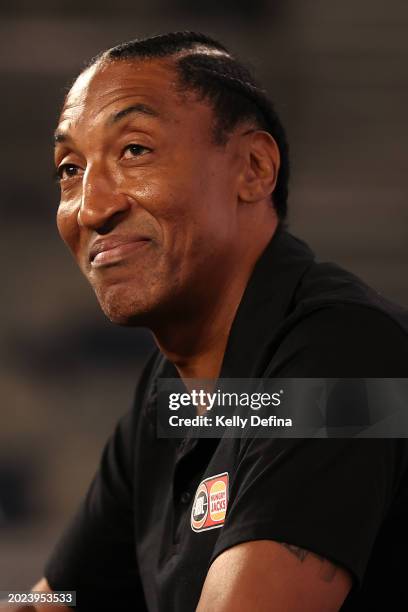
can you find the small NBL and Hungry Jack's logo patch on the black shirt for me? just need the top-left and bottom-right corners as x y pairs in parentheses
(191, 472), (228, 531)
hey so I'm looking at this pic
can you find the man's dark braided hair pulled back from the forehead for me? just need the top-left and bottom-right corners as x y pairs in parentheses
(91, 32), (289, 221)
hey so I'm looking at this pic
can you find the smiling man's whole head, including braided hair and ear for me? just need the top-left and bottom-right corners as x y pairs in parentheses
(55, 33), (288, 327)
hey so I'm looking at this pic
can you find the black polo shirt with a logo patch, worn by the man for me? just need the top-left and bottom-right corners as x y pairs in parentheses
(45, 229), (408, 612)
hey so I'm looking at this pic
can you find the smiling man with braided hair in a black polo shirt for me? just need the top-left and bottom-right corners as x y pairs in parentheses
(9, 32), (408, 612)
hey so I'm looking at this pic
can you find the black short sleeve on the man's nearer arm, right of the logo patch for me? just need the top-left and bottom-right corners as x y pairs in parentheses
(213, 305), (408, 583)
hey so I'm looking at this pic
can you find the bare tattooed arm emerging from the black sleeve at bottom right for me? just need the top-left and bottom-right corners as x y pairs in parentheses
(197, 540), (352, 612)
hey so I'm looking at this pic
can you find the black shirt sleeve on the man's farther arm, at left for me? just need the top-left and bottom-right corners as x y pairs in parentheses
(45, 413), (147, 611)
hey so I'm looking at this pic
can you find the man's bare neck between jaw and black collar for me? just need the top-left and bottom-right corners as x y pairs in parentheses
(152, 215), (276, 380)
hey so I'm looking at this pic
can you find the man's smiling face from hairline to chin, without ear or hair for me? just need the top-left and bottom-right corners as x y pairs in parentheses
(55, 60), (244, 325)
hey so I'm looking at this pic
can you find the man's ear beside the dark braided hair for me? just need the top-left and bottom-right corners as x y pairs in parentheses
(238, 130), (280, 203)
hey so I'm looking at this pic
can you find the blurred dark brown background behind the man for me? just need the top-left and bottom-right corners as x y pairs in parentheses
(0, 0), (408, 590)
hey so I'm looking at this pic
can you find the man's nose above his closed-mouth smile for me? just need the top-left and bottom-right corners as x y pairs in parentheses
(78, 165), (130, 234)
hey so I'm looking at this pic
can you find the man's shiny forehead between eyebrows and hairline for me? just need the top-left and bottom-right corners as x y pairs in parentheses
(59, 59), (202, 129)
